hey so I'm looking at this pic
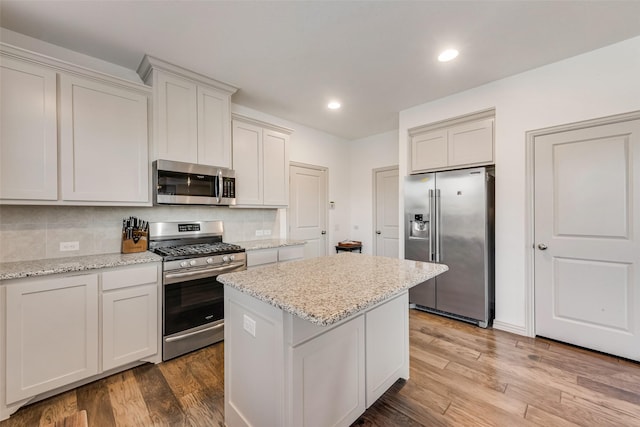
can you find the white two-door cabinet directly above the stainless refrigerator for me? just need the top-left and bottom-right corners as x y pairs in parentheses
(409, 110), (495, 173)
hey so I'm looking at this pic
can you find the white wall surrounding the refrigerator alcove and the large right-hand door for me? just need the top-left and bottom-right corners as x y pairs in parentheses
(398, 37), (640, 334)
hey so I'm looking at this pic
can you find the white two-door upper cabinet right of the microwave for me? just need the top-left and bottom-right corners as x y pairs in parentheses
(233, 116), (292, 207)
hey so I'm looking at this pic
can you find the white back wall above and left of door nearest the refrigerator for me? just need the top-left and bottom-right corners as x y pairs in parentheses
(348, 130), (398, 254)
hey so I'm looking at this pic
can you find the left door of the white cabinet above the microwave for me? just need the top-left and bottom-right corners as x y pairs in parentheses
(154, 71), (198, 163)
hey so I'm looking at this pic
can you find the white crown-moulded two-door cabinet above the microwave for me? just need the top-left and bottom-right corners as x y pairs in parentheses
(138, 55), (237, 168)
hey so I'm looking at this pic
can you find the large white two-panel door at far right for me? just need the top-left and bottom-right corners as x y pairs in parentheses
(534, 119), (640, 360)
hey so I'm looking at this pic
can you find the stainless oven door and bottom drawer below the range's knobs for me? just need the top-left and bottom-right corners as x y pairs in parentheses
(162, 263), (246, 360)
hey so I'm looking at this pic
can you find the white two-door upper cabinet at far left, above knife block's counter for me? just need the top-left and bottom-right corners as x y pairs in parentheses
(0, 45), (151, 206)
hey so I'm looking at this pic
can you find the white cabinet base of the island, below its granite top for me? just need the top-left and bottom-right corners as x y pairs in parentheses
(224, 285), (409, 427)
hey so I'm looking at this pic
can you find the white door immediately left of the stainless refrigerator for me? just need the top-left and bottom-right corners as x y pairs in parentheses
(373, 167), (400, 258)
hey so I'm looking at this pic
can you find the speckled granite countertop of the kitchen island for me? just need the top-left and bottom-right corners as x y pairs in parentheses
(218, 252), (449, 326)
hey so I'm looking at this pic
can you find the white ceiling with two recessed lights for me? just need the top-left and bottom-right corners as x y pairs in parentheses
(0, 0), (640, 140)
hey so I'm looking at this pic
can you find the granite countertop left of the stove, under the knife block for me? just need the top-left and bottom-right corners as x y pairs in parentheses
(0, 251), (162, 280)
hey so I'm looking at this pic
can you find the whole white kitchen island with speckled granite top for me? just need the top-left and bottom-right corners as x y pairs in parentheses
(218, 253), (448, 427)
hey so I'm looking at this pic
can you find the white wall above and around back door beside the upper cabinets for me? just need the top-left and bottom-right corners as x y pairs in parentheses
(232, 104), (351, 254)
